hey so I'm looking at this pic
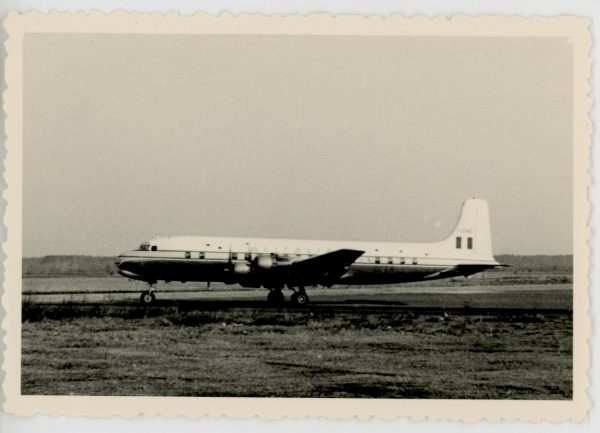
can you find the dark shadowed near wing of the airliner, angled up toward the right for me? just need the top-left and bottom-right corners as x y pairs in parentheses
(288, 249), (365, 286)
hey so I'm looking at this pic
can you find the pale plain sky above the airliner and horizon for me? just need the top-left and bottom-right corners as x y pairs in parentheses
(23, 34), (572, 256)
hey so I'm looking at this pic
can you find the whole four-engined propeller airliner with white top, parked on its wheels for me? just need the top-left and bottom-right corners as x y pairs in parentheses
(116, 198), (503, 305)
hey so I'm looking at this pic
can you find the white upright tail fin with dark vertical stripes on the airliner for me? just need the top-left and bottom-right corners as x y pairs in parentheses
(442, 198), (495, 261)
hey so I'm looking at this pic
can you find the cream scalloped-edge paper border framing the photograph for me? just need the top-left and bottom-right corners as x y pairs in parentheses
(2, 12), (592, 421)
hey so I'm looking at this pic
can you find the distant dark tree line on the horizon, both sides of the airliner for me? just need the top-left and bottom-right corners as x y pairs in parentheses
(23, 255), (573, 277)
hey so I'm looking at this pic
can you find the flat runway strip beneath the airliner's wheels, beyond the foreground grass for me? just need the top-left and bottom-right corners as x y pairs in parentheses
(23, 279), (573, 313)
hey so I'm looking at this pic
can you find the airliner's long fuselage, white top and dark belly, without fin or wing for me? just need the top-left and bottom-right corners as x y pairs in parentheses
(119, 237), (498, 286)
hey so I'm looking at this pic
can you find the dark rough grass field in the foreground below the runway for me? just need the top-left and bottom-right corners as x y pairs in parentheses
(21, 296), (572, 399)
